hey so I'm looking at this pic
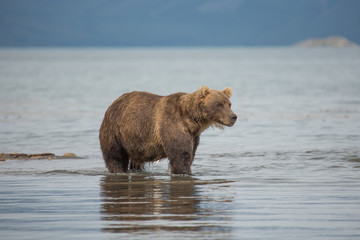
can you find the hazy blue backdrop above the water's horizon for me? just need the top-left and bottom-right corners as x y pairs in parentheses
(0, 0), (360, 47)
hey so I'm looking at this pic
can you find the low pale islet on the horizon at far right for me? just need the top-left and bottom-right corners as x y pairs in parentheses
(295, 37), (358, 47)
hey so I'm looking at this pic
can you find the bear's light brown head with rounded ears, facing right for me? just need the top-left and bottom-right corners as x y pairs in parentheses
(198, 86), (237, 127)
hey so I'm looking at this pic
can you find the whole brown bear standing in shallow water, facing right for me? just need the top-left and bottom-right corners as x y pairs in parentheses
(99, 86), (237, 175)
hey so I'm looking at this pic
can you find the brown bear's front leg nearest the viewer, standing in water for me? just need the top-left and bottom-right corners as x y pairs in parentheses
(162, 133), (194, 175)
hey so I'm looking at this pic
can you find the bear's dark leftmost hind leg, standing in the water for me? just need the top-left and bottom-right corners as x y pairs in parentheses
(103, 145), (129, 173)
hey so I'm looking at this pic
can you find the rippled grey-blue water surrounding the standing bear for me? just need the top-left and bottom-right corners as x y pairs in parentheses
(0, 48), (360, 239)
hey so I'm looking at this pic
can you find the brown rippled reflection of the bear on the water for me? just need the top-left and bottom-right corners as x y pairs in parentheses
(101, 174), (226, 233)
